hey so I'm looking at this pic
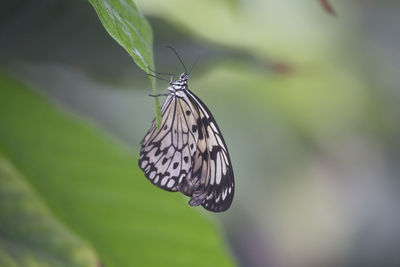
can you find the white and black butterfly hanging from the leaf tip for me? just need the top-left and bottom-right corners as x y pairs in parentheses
(139, 56), (235, 212)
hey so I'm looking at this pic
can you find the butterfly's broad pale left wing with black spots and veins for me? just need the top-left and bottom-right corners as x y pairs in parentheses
(139, 95), (198, 191)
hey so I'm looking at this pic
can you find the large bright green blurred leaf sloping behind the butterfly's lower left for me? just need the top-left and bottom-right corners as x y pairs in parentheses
(0, 75), (234, 267)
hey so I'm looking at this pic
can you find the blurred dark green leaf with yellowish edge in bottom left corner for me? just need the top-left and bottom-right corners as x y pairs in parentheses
(0, 154), (98, 266)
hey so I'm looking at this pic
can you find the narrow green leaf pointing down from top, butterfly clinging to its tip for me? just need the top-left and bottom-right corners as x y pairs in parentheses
(89, 0), (161, 127)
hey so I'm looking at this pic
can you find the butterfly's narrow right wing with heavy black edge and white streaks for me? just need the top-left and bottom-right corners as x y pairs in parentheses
(188, 91), (235, 212)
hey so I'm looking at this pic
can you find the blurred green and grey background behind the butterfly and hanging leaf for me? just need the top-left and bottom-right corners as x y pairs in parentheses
(0, 0), (400, 267)
